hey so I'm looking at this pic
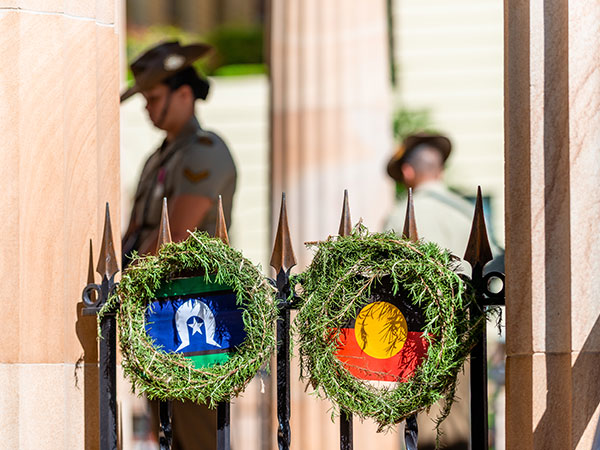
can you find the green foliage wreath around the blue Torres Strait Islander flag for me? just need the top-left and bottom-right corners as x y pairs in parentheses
(103, 232), (277, 407)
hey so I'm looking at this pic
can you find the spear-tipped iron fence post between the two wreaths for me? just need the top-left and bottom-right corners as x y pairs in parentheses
(270, 193), (296, 450)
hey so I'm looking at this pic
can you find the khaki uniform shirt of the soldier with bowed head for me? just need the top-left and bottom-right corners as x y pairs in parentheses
(131, 117), (236, 250)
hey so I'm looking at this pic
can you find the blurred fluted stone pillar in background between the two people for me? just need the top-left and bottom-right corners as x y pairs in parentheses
(270, 0), (399, 450)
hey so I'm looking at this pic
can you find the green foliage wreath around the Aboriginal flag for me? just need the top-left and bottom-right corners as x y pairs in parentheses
(294, 224), (485, 433)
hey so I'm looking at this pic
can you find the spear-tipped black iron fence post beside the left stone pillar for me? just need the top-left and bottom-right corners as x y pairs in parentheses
(82, 203), (119, 450)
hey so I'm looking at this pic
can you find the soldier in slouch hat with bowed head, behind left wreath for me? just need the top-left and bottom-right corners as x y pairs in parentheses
(121, 42), (236, 450)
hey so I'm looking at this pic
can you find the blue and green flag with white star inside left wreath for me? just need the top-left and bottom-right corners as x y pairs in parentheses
(145, 277), (246, 368)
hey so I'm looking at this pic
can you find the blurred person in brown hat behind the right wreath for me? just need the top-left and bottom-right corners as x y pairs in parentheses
(385, 133), (473, 450)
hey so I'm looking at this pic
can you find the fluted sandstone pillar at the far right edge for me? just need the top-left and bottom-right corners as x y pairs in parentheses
(505, 0), (600, 449)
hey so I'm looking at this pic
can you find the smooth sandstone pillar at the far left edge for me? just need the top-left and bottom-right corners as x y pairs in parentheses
(0, 0), (120, 449)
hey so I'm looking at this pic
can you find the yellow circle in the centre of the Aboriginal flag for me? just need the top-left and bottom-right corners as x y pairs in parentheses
(354, 302), (408, 359)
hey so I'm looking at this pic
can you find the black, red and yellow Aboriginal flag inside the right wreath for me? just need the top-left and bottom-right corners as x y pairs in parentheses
(336, 280), (428, 382)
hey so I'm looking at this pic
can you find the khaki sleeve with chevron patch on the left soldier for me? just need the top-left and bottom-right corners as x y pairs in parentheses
(174, 135), (236, 200)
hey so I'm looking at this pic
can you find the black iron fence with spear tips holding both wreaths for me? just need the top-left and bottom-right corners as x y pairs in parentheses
(83, 189), (504, 450)
